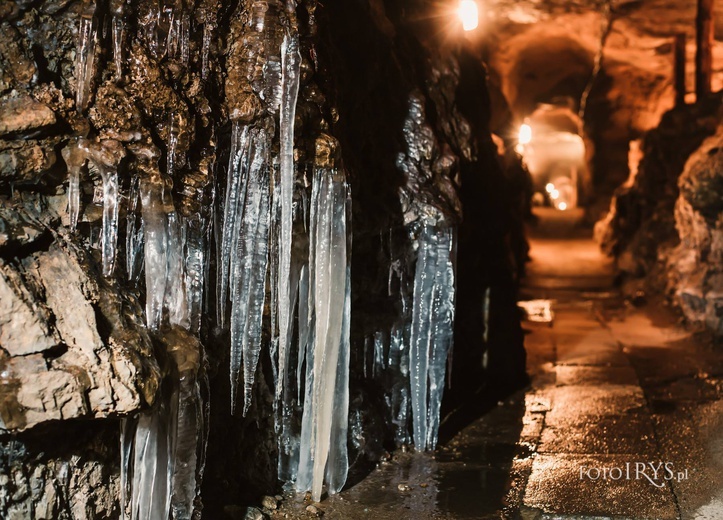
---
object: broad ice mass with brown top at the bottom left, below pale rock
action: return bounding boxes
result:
[121,328,206,520]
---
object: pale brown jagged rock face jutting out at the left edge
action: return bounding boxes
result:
[0,201,159,432]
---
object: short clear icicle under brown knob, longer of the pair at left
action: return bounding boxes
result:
[81,139,126,276]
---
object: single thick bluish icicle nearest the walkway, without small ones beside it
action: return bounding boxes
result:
[409,223,454,451]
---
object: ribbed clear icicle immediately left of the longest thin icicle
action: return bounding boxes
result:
[230,128,271,415]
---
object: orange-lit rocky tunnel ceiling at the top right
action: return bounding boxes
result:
[482,0,723,139]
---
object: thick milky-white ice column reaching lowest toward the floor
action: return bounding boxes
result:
[296,162,351,501]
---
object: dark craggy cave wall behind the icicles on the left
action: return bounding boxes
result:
[0,0,525,519]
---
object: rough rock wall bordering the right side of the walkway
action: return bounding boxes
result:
[595,94,723,337]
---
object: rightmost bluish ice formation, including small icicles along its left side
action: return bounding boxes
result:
[367,217,456,451]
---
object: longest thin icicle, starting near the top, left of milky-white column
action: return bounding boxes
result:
[276,22,301,399]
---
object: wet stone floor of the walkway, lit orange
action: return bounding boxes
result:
[272,210,723,520]
